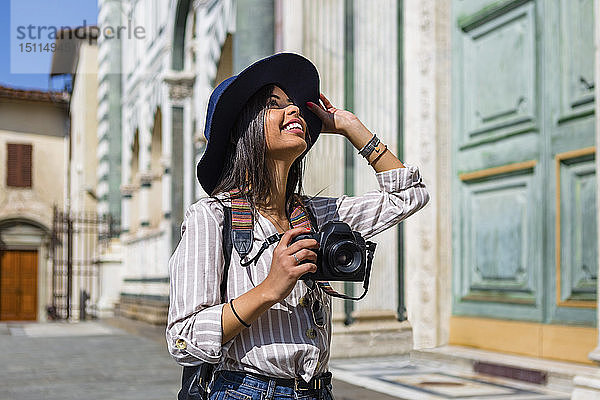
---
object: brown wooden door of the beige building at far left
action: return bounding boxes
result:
[0,251,38,321]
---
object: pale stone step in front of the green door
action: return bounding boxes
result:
[410,345,598,392]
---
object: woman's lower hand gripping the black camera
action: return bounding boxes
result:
[260,227,319,301]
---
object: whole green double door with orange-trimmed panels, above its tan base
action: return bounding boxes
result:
[452,0,598,325]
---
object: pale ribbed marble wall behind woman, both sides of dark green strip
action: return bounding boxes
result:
[278,0,398,319]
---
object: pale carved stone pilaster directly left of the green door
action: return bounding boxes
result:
[402,0,452,348]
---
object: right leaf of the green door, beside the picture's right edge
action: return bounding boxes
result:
[540,0,598,325]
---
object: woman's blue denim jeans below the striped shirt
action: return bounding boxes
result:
[209,371,334,400]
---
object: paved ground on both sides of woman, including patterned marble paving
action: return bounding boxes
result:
[0,318,570,400]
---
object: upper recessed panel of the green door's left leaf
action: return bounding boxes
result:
[461,4,536,146]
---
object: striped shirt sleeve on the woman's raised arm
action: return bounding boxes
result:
[310,164,429,239]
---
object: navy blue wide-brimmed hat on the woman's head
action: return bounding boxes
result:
[196,53,322,194]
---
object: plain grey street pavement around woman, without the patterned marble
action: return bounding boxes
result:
[0,318,397,400]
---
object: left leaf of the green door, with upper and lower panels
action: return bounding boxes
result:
[452,0,544,321]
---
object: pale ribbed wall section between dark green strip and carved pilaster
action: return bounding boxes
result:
[354,0,399,318]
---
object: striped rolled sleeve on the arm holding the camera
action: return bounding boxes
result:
[166,201,228,366]
